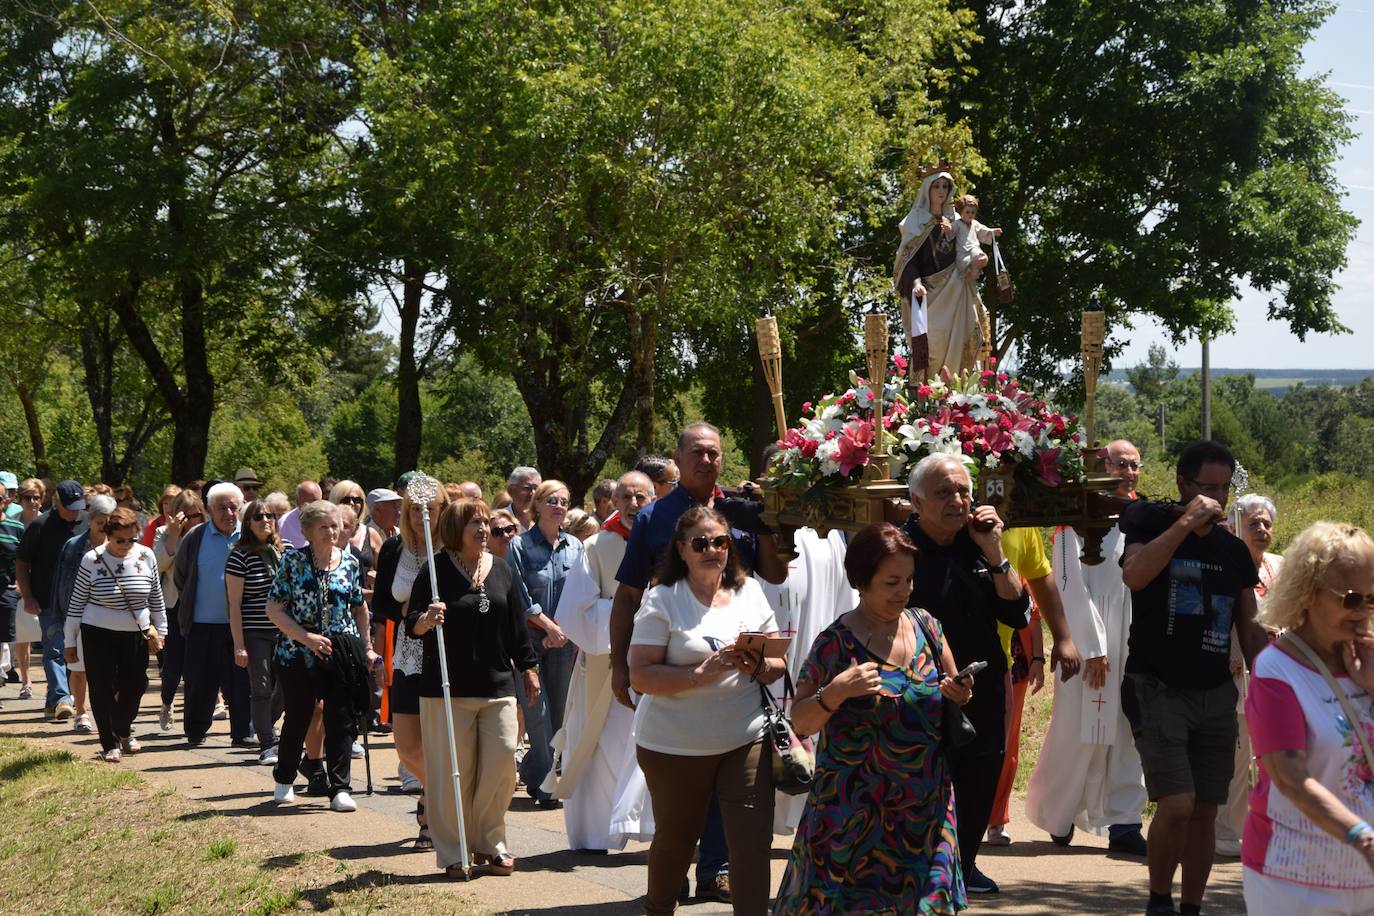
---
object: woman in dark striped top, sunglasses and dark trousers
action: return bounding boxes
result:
[224,500,282,766]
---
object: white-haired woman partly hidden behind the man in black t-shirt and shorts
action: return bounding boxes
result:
[1216,493,1283,858]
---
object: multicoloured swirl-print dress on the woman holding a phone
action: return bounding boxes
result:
[774,611,967,916]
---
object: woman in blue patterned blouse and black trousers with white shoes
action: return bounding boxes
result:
[267,500,381,812]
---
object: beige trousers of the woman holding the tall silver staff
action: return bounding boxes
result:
[420,696,517,868]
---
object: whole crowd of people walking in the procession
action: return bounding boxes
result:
[0,422,1374,916]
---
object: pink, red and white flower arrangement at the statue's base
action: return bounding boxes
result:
[768,354,1084,489]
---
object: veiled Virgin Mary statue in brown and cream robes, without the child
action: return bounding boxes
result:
[892,163,984,378]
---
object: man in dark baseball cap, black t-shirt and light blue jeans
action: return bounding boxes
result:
[15,481,85,721]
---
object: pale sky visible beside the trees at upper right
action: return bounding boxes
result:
[1116,0,1374,369]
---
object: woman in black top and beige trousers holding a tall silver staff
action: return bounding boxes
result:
[405,500,539,878]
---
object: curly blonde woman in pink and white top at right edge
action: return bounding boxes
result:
[1241,522,1374,916]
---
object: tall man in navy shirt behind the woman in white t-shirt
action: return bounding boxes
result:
[610,422,787,901]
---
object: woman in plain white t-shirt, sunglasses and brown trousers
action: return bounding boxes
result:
[629,507,783,913]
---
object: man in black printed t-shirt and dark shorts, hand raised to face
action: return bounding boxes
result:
[1121,441,1265,916]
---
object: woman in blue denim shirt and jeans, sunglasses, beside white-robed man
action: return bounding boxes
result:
[507,481,583,808]
